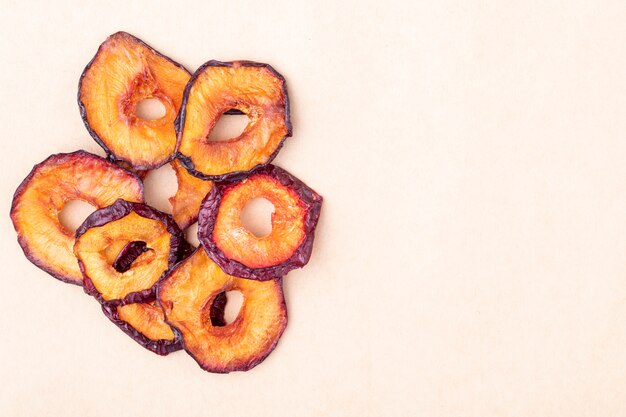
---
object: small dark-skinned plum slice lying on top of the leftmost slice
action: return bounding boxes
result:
[74,200,188,303]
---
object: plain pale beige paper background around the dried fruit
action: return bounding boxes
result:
[0,0,626,417]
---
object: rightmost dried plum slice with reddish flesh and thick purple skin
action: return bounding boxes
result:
[198,165,322,281]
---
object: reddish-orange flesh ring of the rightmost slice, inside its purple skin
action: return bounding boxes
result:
[213,175,306,268]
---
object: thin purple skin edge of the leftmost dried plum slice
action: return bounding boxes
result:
[11,149,144,286]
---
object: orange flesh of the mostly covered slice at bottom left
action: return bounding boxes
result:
[117,301,174,340]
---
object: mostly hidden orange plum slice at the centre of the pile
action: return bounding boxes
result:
[169,160,213,229]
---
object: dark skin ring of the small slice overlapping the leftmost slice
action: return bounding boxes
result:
[76,199,189,304]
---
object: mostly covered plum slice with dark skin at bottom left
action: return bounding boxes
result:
[102,290,182,356]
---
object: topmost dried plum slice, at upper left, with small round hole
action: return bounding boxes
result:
[78,32,190,170]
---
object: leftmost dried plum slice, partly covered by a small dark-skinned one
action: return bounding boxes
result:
[11,151,143,285]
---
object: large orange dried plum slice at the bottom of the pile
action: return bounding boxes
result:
[157,247,287,373]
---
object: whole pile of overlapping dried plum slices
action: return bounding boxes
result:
[11,32,322,373]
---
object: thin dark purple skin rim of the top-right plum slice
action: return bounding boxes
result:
[174,60,293,181]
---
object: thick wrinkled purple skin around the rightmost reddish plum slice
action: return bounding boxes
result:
[198,165,323,281]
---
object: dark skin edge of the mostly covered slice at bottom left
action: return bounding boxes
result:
[102,286,182,356]
